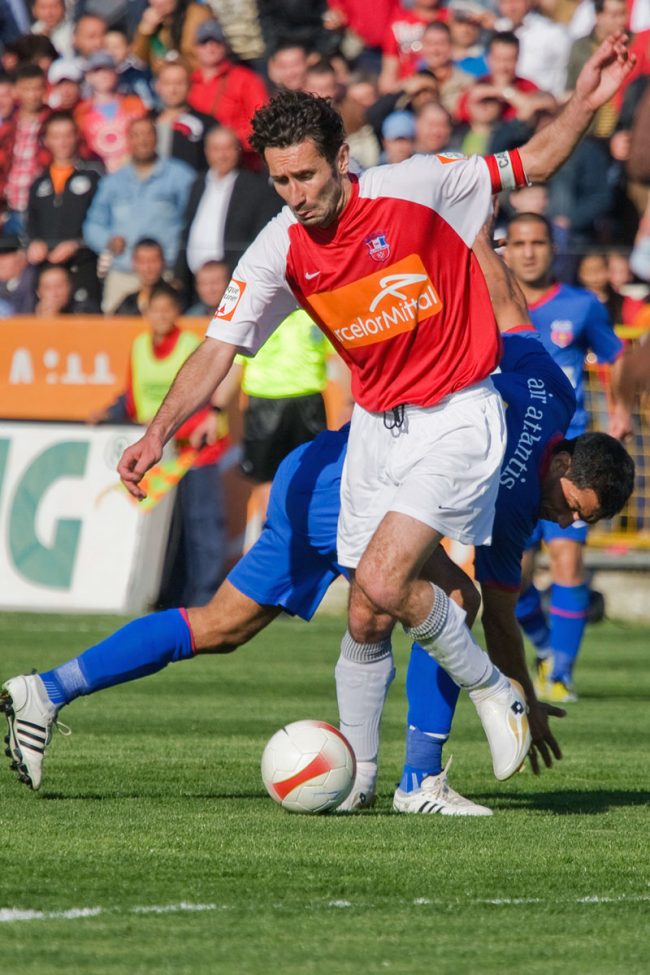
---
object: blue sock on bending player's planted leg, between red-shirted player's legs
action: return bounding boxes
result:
[400,643,460,792]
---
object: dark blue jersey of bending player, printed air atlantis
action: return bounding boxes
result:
[475,331,576,591]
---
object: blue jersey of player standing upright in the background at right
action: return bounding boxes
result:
[529,284,622,437]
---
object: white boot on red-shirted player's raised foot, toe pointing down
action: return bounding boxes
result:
[469,674,532,781]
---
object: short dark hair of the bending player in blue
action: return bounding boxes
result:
[553,433,634,518]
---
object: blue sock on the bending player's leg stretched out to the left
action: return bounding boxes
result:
[40,609,193,707]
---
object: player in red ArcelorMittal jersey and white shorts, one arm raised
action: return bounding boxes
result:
[118,35,633,779]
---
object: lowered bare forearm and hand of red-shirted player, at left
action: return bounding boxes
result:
[117,338,237,501]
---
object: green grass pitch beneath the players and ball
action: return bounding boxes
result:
[0,614,650,975]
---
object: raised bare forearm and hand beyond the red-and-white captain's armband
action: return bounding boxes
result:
[519,32,636,183]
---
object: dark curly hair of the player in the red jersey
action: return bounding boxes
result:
[250,91,345,165]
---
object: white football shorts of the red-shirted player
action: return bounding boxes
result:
[337,379,506,568]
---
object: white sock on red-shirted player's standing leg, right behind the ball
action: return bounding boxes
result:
[334,633,395,773]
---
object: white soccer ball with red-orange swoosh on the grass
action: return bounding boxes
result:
[262,721,357,813]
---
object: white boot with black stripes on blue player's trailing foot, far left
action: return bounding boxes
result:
[0,674,56,790]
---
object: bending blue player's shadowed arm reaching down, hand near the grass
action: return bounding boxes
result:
[482,586,566,775]
